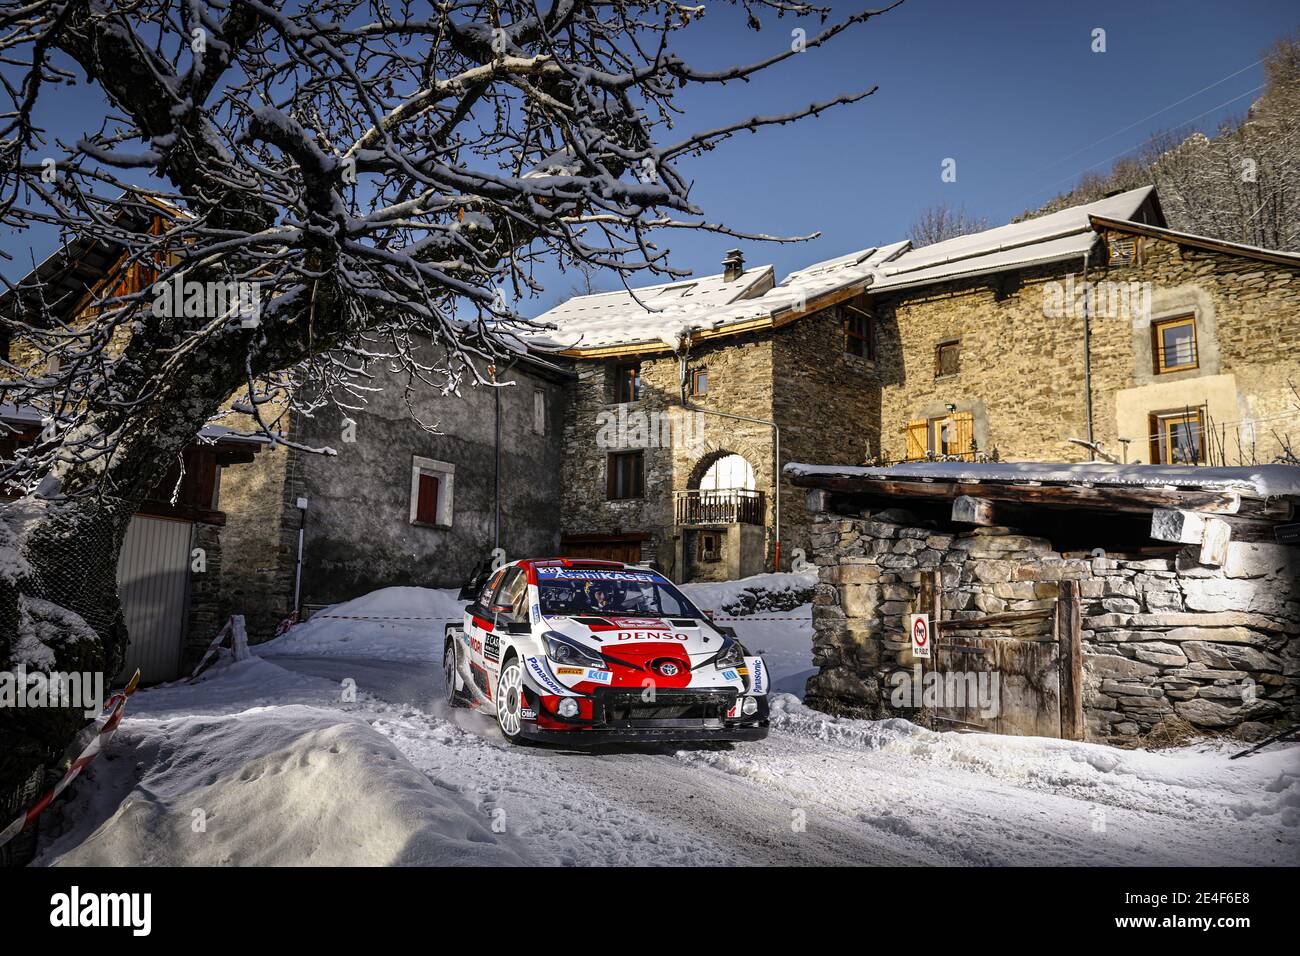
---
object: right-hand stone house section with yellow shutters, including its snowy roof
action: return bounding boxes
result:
[863,187,1300,466]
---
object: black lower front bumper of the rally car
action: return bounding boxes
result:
[520,688,768,747]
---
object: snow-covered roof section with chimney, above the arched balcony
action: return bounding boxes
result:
[532,265,772,349]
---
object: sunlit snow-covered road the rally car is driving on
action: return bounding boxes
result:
[276,657,1300,865]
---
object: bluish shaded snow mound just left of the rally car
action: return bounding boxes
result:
[257,588,465,661]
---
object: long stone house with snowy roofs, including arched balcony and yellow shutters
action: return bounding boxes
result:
[538,187,1300,580]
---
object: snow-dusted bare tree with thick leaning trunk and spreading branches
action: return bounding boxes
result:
[0,0,897,790]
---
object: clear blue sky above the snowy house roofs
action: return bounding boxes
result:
[0,0,1300,315]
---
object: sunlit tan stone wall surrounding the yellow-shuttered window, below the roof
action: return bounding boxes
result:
[873,238,1300,464]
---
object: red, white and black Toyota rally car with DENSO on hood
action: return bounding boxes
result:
[442,558,768,747]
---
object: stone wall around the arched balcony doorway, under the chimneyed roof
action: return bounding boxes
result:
[564,307,880,575]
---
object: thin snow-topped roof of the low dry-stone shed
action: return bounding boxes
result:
[785,462,1300,498]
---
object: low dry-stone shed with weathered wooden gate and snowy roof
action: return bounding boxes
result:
[787,462,1300,743]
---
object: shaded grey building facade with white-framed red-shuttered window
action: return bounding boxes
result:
[221,348,568,640]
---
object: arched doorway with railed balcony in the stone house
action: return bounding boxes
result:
[673,447,767,581]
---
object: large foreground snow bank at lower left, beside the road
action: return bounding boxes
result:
[36,681,524,866]
